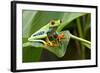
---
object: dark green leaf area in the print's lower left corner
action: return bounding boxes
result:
[22,46,42,63]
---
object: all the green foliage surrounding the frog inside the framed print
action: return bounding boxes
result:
[22,10,91,62]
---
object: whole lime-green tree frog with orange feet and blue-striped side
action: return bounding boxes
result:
[28,20,64,46]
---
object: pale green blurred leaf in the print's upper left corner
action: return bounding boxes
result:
[22,10,37,38]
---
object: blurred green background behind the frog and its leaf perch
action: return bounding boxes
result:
[22,10,91,63]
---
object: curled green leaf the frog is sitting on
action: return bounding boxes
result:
[23,31,70,57]
